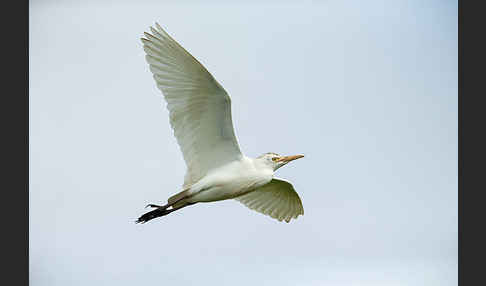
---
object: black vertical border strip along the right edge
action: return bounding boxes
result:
[458,1,486,285]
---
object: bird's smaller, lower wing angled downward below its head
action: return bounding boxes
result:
[235,178,304,222]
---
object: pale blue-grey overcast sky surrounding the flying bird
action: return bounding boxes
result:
[29,0,458,286]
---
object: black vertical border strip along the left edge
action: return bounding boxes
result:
[0,1,29,285]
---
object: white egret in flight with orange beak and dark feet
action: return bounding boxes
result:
[135,22,304,223]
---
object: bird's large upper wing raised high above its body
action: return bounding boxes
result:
[142,23,242,188]
